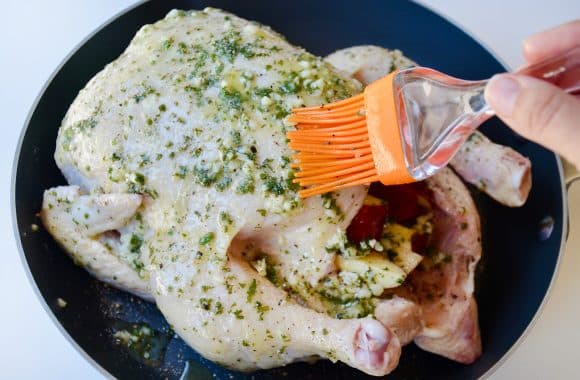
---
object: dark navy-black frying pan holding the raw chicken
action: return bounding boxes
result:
[13,0,566,379]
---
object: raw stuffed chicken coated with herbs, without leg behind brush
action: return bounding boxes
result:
[41,8,532,376]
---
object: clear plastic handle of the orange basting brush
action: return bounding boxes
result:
[402,46,580,180]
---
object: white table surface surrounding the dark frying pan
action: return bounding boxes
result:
[0,0,580,379]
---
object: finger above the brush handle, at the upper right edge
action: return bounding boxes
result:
[523,20,580,64]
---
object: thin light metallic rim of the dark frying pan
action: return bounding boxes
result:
[10,0,569,379]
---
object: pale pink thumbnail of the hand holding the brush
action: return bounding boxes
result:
[485,74,520,116]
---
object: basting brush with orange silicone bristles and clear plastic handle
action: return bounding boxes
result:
[288,47,580,197]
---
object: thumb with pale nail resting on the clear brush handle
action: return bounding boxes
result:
[485,74,580,168]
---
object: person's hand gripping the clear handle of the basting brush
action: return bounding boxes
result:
[485,20,580,169]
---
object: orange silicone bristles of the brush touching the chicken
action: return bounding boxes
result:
[287,94,378,198]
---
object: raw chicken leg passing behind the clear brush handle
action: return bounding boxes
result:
[325,45,532,207]
